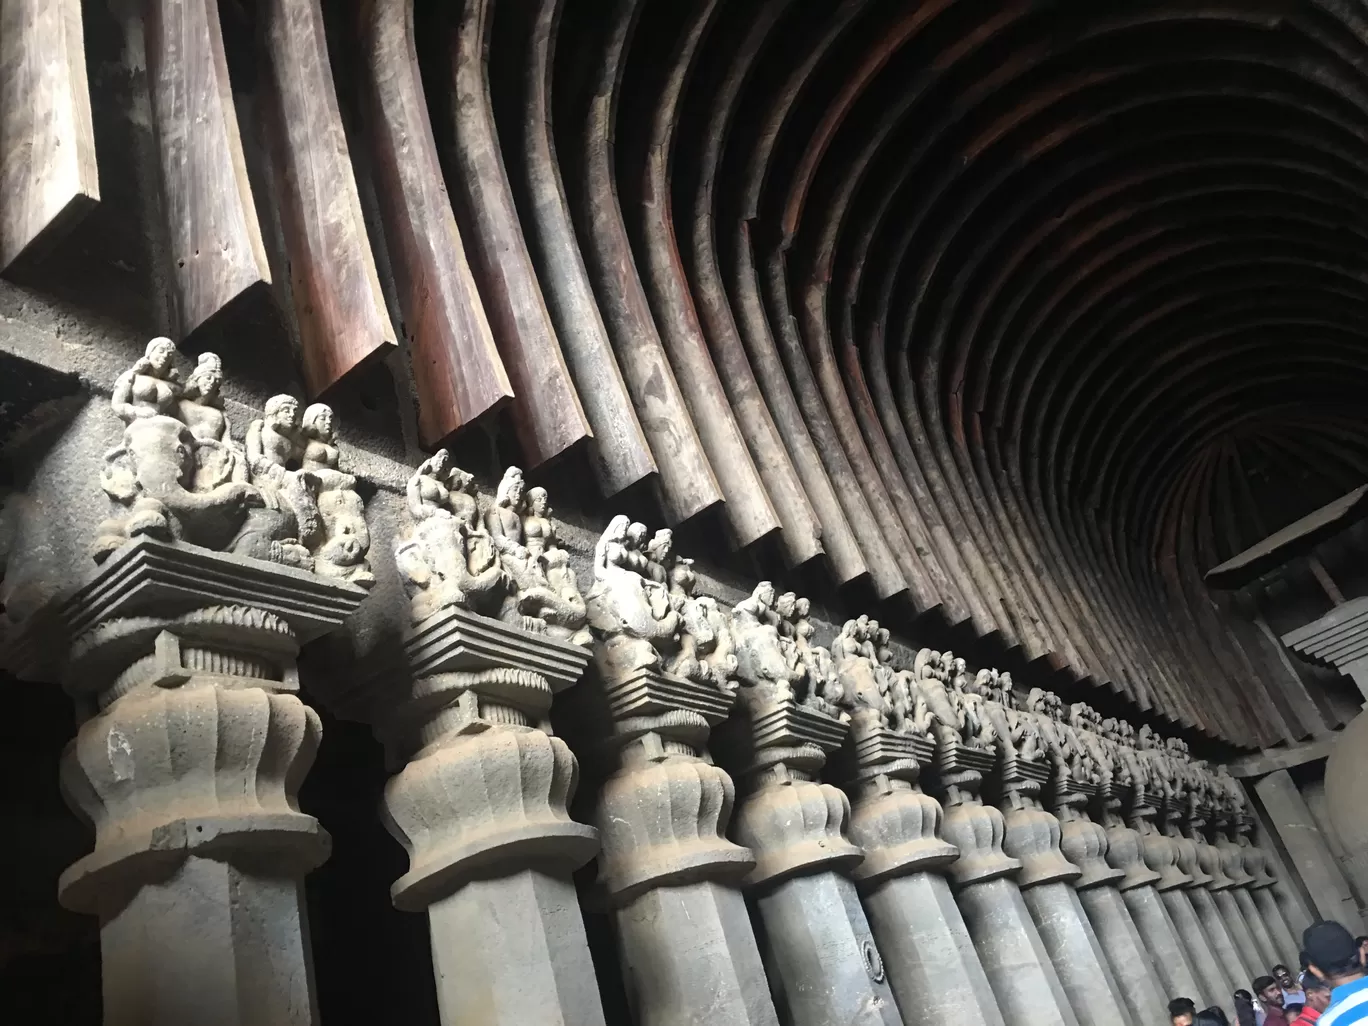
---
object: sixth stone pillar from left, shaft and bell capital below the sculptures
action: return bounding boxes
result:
[936,737,1078,1026]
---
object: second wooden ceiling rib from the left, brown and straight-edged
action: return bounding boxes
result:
[144,0,271,339]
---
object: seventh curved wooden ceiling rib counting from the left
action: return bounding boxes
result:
[572,0,722,524]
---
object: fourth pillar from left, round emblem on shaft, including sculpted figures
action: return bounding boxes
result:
[714,583,903,1026]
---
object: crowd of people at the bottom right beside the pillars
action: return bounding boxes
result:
[1168,921,1368,1026]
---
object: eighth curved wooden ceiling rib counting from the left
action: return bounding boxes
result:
[624,0,791,555]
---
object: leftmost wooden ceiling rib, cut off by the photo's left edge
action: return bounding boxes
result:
[0,0,100,271]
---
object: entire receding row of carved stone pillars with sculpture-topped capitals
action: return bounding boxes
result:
[2,339,1313,1026]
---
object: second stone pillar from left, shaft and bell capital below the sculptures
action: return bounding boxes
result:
[345,607,603,1026]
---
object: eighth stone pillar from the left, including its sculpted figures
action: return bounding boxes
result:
[1026,688,1167,1026]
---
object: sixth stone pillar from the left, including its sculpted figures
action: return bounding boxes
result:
[918,653,1078,1026]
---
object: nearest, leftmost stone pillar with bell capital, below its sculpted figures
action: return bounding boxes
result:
[52,538,365,1026]
